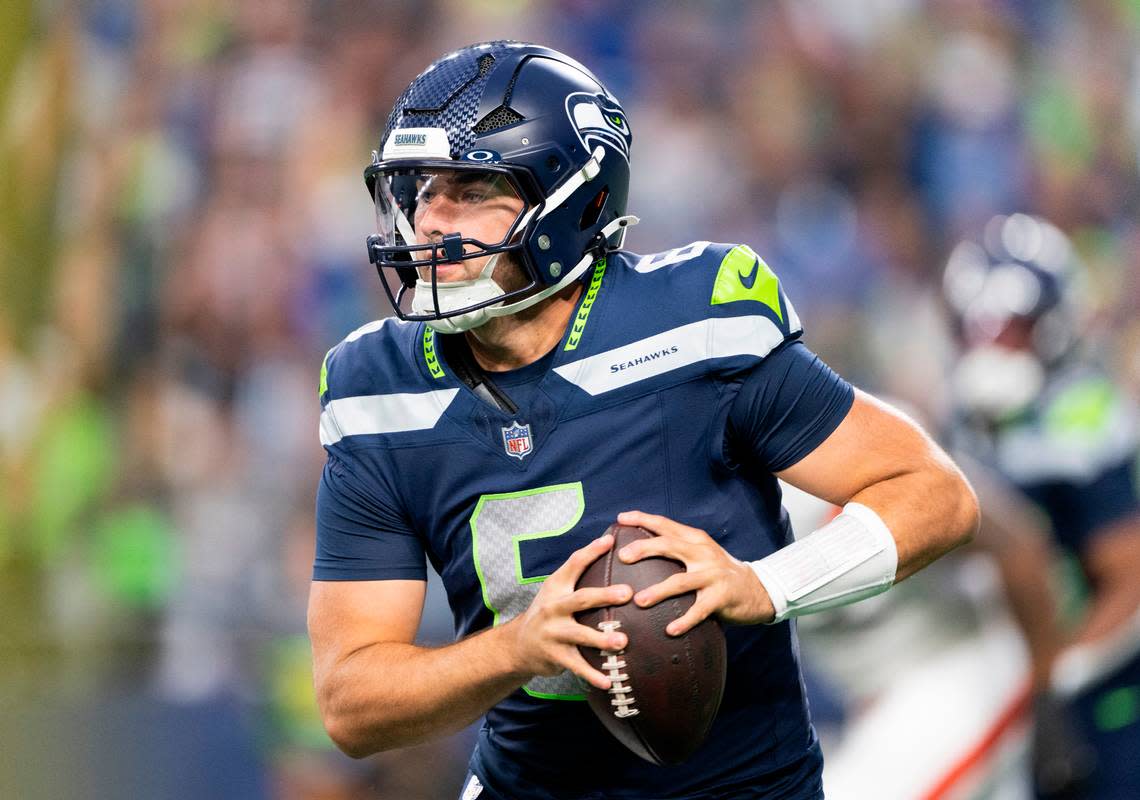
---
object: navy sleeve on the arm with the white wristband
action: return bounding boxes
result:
[725,341,855,472]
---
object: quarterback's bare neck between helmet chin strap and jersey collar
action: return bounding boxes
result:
[466,284,583,373]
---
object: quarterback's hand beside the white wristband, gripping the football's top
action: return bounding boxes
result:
[618,511,775,636]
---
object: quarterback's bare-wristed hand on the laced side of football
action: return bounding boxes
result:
[507,534,633,689]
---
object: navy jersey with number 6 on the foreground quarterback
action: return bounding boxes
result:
[314,243,853,798]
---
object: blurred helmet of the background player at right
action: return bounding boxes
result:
[943,214,1086,418]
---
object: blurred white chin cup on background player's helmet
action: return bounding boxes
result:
[953,344,1045,418]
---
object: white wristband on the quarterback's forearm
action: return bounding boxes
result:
[748,503,898,622]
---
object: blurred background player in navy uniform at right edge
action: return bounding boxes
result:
[943,214,1140,798]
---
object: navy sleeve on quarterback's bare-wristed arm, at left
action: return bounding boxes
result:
[312,455,428,580]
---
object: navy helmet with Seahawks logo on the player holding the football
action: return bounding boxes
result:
[365,41,636,333]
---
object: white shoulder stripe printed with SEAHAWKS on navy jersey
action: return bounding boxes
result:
[554,316,784,394]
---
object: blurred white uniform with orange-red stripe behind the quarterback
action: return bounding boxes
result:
[782,484,1032,800]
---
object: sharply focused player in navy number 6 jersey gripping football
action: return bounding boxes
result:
[309,42,977,800]
